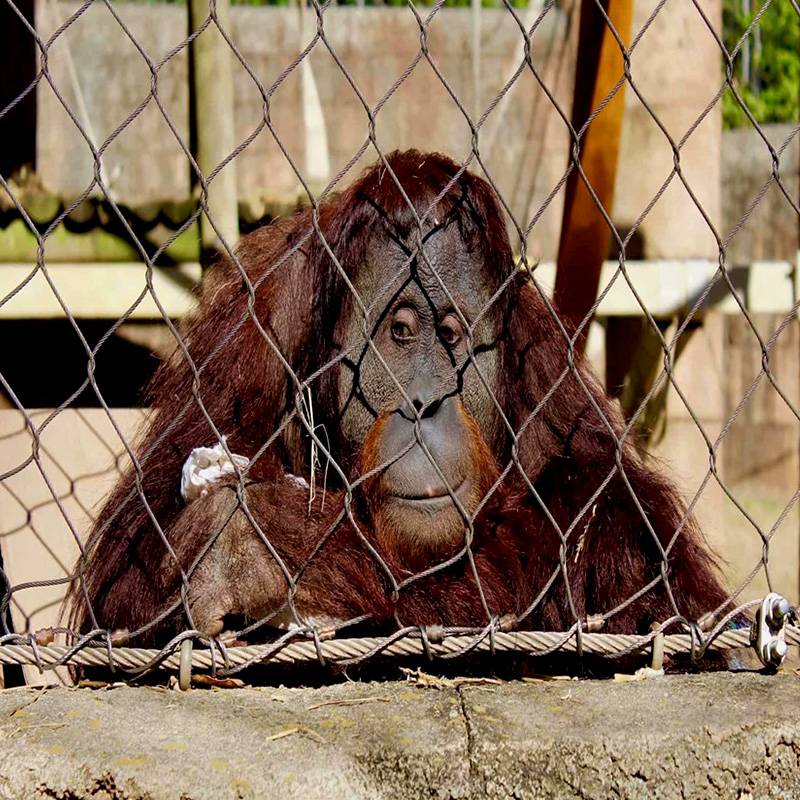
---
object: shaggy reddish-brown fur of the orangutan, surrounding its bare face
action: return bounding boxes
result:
[71,152,725,641]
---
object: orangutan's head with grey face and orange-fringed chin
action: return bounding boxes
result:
[318,152,513,562]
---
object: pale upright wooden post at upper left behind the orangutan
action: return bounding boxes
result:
[189,0,239,265]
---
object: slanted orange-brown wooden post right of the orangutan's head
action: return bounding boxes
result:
[554,0,633,350]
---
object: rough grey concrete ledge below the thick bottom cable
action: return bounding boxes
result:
[0,674,800,800]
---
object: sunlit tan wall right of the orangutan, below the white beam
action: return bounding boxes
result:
[655,313,800,602]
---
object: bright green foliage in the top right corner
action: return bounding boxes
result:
[722,0,800,128]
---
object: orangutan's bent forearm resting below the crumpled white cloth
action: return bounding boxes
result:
[161,476,389,636]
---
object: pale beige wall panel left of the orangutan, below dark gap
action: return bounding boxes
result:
[0,409,144,679]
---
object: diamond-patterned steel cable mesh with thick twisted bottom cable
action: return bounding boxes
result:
[0,0,800,674]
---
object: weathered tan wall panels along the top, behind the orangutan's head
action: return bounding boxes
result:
[37,0,721,260]
